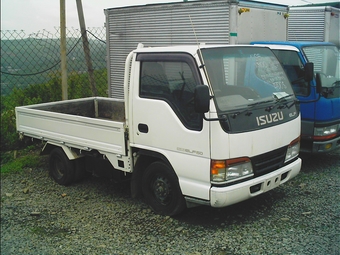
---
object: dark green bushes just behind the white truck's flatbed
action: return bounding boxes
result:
[1,69,107,151]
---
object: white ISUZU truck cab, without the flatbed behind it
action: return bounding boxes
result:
[125,45,301,214]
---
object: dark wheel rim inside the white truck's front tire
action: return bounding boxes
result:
[151,176,171,205]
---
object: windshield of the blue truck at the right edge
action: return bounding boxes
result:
[303,45,340,87]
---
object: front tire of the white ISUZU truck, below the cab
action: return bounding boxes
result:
[142,161,186,216]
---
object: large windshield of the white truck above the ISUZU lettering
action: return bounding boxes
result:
[202,46,294,111]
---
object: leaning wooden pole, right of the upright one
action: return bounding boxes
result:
[76,0,97,96]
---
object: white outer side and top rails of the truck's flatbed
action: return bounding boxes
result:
[16,98,130,171]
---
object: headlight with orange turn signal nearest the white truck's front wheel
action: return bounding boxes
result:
[211,158,253,183]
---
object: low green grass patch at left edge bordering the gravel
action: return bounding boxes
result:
[1,145,43,176]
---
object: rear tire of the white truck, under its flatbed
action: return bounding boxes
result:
[49,148,75,186]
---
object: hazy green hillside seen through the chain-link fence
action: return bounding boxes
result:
[0,35,106,95]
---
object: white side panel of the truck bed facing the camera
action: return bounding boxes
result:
[17,108,125,154]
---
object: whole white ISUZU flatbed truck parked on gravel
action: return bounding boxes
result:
[16,45,301,215]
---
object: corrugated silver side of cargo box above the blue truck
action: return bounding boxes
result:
[288,8,325,42]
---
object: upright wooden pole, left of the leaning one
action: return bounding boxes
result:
[60,0,68,100]
